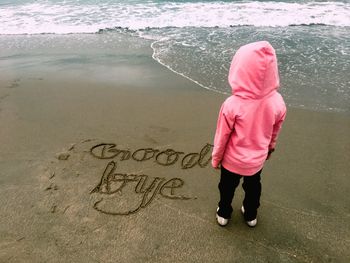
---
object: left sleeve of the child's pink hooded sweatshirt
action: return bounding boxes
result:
[212,103,235,168]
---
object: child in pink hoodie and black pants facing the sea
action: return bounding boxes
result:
[212,41,286,227]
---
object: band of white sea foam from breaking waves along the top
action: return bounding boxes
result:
[0,1,350,34]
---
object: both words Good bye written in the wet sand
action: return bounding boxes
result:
[90,143,213,215]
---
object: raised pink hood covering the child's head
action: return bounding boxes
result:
[228,41,279,99]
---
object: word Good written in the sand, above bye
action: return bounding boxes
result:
[90,143,213,169]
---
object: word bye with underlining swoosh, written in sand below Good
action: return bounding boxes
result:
[91,161,191,215]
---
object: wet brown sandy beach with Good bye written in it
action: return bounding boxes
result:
[0,33,350,263]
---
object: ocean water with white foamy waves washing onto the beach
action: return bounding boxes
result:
[0,0,350,113]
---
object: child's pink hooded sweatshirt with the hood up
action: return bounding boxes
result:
[212,41,286,176]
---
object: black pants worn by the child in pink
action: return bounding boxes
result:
[218,166,262,221]
